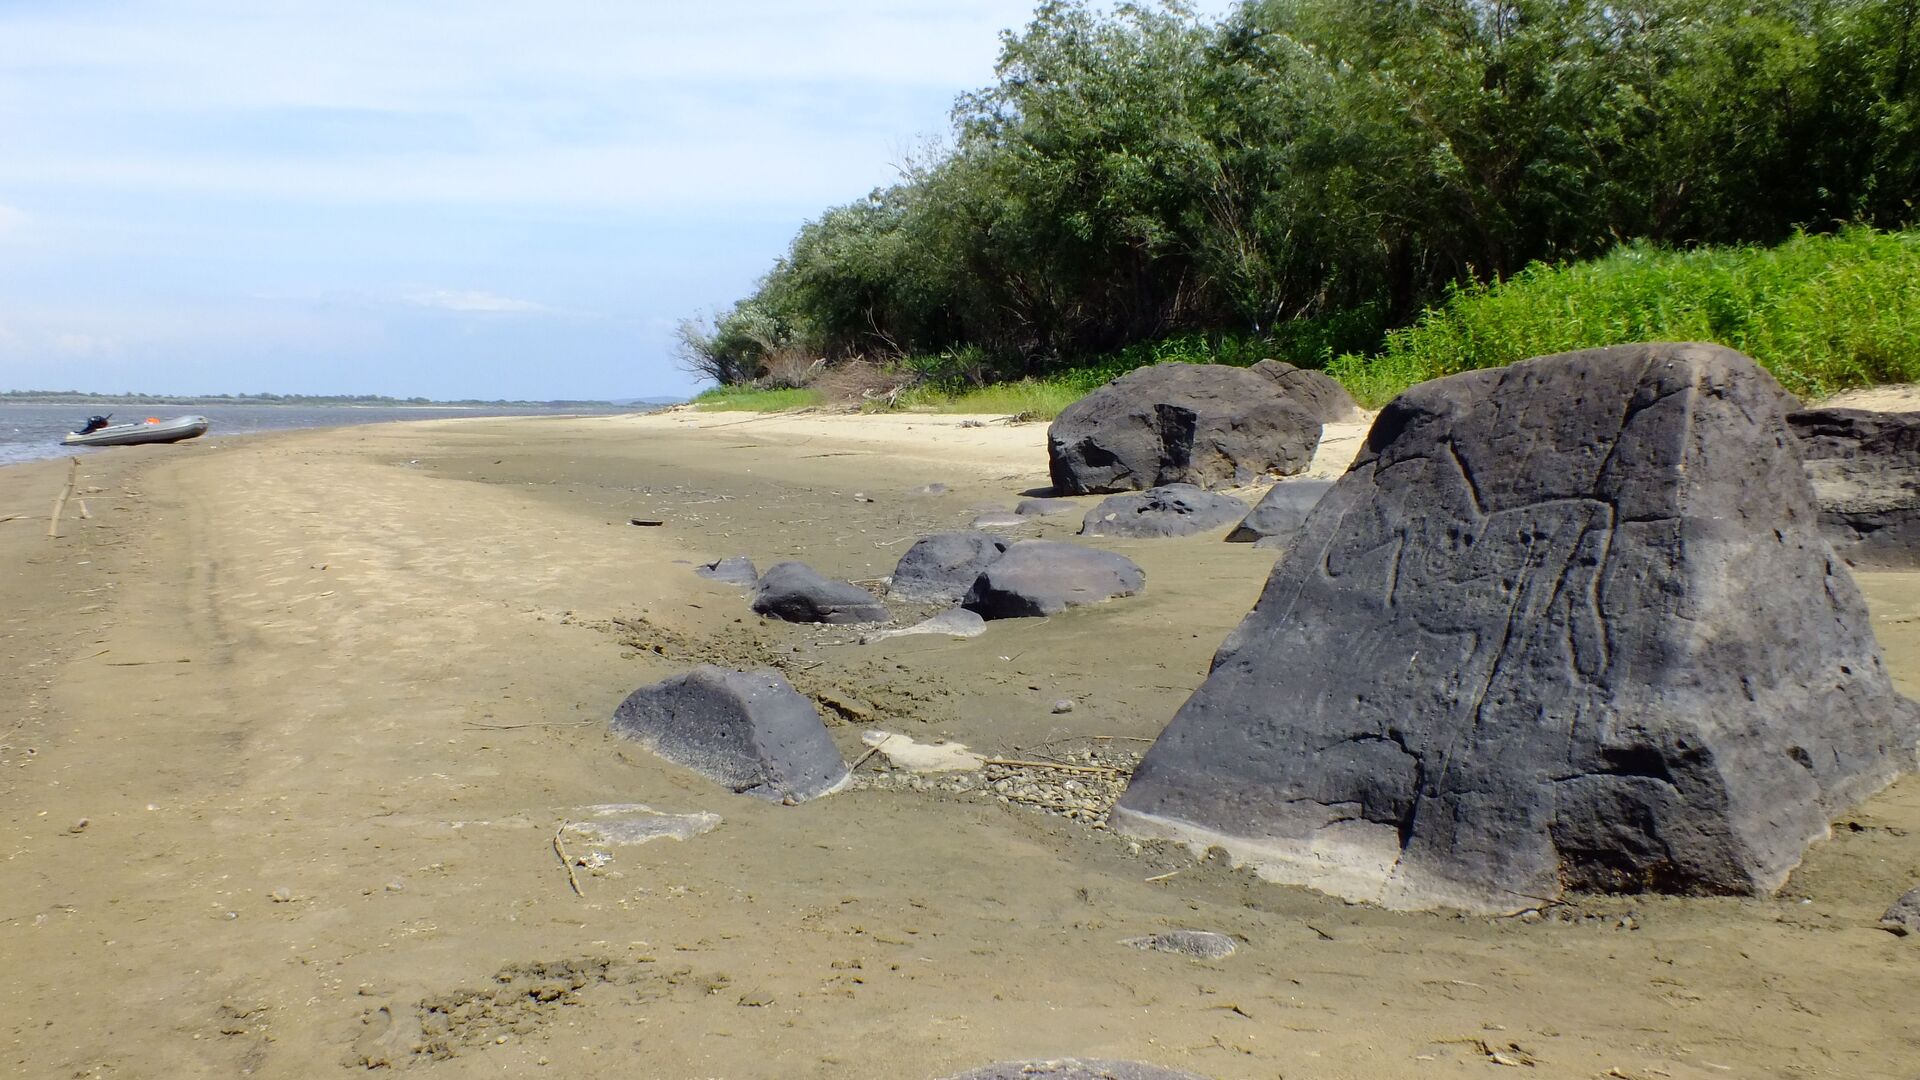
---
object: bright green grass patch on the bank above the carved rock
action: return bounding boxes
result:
[1327,229,1920,405]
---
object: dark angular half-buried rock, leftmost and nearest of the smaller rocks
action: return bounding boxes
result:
[612,665,847,803]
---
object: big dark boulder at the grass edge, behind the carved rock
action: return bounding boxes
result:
[1046,363,1321,496]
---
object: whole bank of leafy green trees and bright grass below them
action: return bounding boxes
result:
[680,0,1920,419]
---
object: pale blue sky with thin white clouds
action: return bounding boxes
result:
[0,0,1213,400]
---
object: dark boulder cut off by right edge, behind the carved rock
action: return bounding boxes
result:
[1788,409,1920,569]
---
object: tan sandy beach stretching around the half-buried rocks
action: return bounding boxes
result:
[0,411,1920,1080]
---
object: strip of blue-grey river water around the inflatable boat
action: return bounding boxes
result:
[0,402,629,465]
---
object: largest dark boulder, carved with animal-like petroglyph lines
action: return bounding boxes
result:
[1114,344,1920,913]
